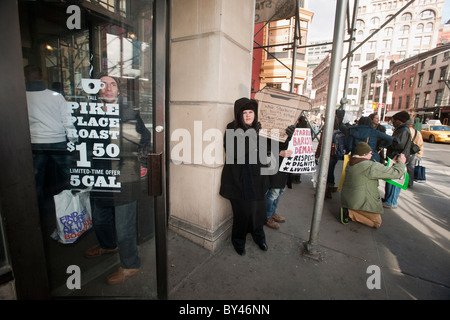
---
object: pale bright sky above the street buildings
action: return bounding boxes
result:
[306,0,450,42]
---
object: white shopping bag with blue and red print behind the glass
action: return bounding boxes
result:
[52,189,92,244]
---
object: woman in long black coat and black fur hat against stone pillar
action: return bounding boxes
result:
[219,98,269,255]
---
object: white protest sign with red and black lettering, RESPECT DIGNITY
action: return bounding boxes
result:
[279,128,316,173]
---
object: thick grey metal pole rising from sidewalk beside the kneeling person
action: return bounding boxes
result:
[305,0,347,255]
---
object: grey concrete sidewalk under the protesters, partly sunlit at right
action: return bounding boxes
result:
[168,162,450,300]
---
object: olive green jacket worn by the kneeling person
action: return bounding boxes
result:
[341,158,406,214]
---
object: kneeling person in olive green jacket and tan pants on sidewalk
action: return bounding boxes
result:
[340,142,406,228]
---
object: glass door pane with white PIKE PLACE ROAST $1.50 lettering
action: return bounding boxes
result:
[18,0,165,299]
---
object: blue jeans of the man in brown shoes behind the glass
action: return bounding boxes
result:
[92,200,141,269]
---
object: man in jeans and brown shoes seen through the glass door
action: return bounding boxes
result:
[85,73,151,284]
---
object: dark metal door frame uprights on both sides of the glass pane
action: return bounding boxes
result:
[0,0,170,300]
